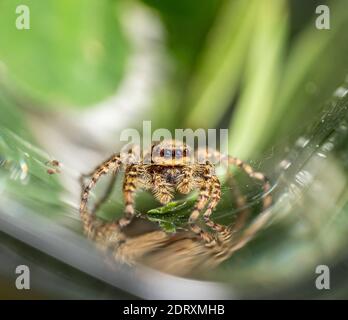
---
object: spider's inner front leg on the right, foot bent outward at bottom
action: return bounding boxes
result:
[189,166,215,243]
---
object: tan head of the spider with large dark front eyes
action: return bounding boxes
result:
[151,140,192,166]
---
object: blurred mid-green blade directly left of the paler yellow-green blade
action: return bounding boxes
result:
[185,0,259,128]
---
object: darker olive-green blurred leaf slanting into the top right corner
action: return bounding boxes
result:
[258,0,348,154]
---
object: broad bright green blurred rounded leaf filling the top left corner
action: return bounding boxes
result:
[0,0,128,107]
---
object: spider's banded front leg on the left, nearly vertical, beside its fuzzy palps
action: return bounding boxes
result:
[118,165,139,228]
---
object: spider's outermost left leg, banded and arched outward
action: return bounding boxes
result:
[80,155,121,237]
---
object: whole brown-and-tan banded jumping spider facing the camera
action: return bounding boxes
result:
[80,140,272,243]
